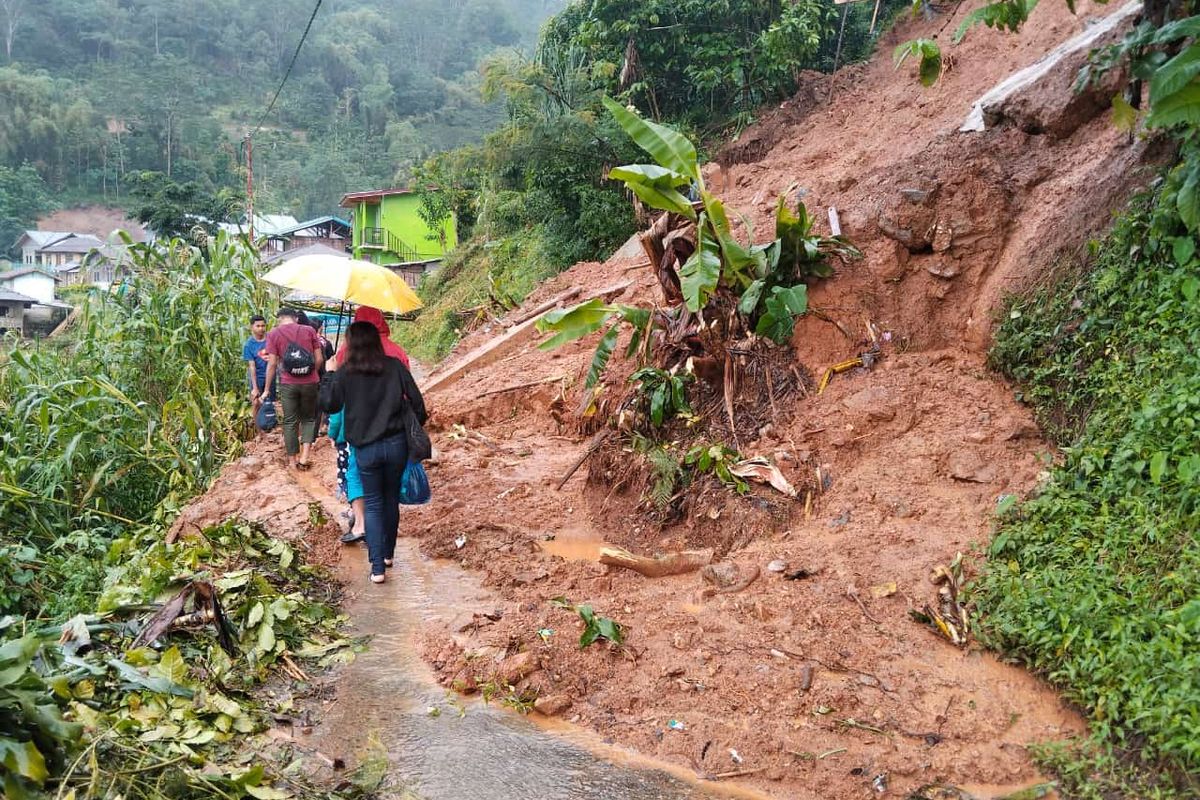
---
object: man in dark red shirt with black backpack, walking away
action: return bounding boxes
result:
[264,308,325,469]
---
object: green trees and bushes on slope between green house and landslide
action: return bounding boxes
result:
[393,0,905,360]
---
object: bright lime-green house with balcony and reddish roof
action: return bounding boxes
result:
[342,188,458,283]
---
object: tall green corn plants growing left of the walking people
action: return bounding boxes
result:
[0,235,269,568]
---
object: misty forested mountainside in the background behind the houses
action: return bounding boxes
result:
[0,0,563,216]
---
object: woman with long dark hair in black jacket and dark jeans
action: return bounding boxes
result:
[322,323,427,583]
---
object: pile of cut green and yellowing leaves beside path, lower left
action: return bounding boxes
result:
[0,523,359,800]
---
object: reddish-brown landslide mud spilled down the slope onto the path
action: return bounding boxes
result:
[181,0,1160,799]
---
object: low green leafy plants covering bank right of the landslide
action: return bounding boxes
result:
[973,185,1200,798]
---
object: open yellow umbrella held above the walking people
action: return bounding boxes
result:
[263,255,424,314]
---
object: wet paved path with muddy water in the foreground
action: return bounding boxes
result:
[312,540,766,800]
